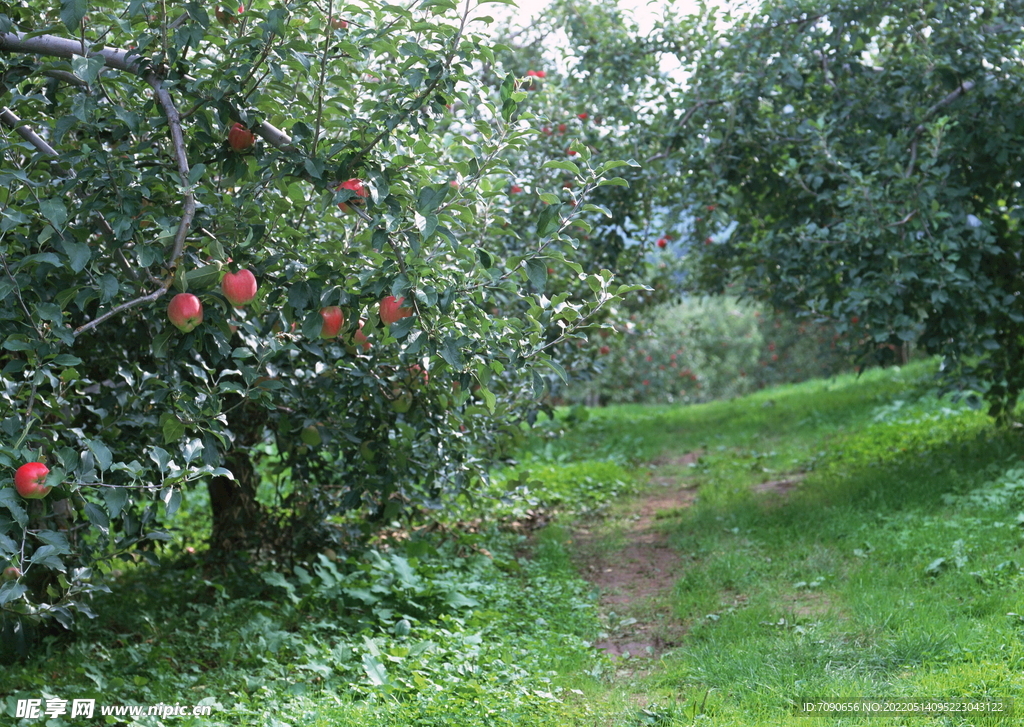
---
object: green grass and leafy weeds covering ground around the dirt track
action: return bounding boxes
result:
[8,361,1024,727]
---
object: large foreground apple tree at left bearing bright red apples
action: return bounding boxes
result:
[0,0,634,638]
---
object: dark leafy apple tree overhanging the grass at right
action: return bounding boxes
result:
[677,0,1024,420]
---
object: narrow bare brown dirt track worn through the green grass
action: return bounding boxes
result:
[571,453,699,657]
